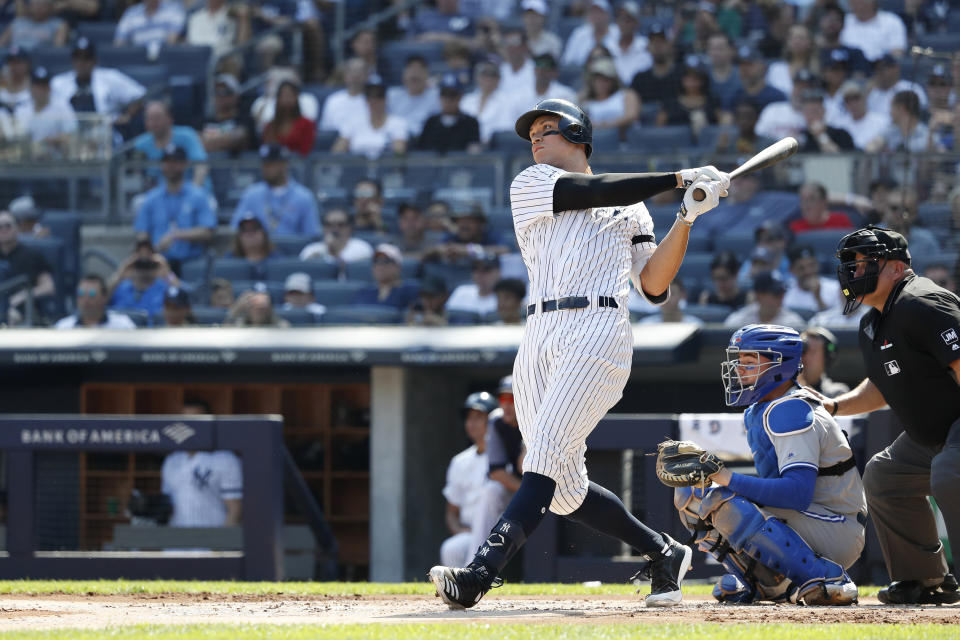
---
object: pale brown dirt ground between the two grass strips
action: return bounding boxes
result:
[0,594,960,631]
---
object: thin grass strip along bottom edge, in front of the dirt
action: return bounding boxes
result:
[0,623,958,640]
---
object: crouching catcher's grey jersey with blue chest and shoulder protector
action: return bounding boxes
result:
[743,387,866,514]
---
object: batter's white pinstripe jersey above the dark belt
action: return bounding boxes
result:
[510,164,657,304]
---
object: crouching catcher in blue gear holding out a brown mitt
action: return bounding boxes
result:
[657,324,867,605]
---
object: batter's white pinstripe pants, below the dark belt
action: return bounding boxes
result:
[513,304,633,515]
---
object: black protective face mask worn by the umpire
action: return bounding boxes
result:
[836,226,910,314]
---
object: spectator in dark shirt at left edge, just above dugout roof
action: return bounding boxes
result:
[0,211,57,324]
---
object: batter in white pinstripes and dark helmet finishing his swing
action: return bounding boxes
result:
[429,99,729,607]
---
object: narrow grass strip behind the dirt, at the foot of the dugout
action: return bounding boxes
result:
[0,580,879,597]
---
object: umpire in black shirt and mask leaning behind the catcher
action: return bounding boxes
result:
[823,226,960,604]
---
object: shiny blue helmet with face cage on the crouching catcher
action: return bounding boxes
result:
[720,324,803,407]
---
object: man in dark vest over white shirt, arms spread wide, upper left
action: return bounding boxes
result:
[50,38,147,127]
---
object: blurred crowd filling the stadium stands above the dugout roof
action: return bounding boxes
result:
[0,0,960,329]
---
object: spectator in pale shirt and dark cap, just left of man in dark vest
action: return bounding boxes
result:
[14,67,77,157]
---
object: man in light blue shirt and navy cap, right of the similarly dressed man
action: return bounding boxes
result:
[230,145,320,238]
